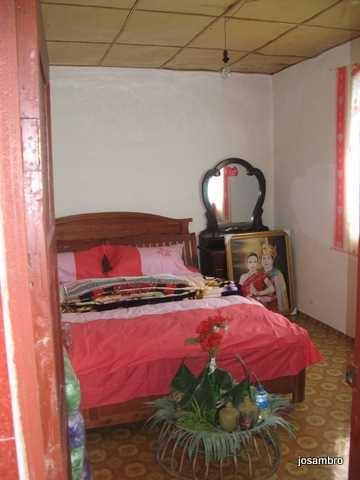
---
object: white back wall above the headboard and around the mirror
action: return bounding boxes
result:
[50,67,273,231]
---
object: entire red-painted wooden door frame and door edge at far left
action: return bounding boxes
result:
[0,0,70,480]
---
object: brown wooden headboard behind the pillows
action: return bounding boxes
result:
[56,212,198,267]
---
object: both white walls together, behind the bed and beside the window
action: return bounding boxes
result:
[51,47,359,334]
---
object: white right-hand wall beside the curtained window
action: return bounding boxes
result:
[273,43,356,334]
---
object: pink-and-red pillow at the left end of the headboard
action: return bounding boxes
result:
[57,245,106,283]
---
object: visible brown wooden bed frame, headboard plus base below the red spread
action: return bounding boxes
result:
[56,212,305,428]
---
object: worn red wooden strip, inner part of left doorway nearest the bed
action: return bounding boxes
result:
[17,0,70,472]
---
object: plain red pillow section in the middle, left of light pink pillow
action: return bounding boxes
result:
[104,245,142,277]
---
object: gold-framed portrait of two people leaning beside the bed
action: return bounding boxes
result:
[226,230,295,314]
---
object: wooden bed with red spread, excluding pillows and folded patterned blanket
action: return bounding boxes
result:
[56,212,320,428]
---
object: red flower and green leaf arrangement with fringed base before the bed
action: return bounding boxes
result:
[150,315,292,478]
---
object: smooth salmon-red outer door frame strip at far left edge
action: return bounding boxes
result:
[0,2,45,479]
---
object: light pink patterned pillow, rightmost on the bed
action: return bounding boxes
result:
[138,243,192,275]
